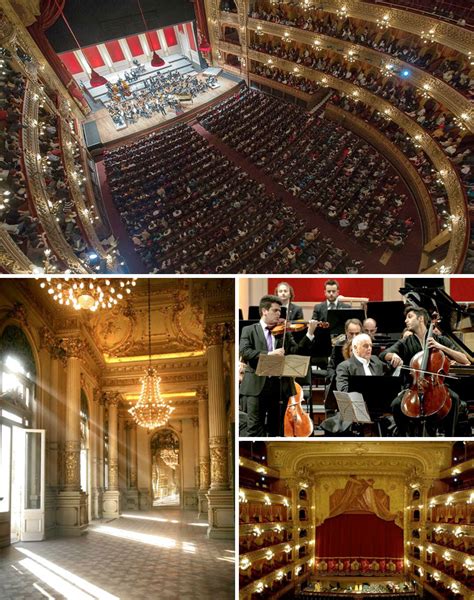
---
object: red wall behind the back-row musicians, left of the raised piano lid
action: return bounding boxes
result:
[268,275,383,303]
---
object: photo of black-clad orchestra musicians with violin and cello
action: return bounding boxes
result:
[238,275,474,438]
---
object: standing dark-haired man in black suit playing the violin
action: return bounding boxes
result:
[239,295,317,437]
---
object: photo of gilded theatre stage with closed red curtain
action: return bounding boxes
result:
[239,441,474,600]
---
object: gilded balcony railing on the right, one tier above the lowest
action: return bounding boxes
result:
[248,18,474,132]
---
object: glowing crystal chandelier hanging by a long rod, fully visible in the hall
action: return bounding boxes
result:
[128,279,174,430]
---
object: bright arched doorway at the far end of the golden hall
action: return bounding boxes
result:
[151,429,181,506]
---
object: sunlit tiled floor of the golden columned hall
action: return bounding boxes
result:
[0,509,234,600]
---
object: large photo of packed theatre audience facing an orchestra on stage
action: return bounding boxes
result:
[0,0,474,274]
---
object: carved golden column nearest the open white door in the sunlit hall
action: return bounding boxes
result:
[57,338,88,535]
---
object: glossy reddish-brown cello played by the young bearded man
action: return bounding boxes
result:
[401,315,452,420]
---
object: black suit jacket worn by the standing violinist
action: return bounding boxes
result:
[239,323,312,396]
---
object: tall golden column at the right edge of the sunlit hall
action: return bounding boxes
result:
[205,323,234,538]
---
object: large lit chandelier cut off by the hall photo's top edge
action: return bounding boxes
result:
[40,277,136,312]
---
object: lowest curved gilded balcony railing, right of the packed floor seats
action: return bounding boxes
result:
[248,50,469,273]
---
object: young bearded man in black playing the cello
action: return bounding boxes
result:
[379,306,470,436]
